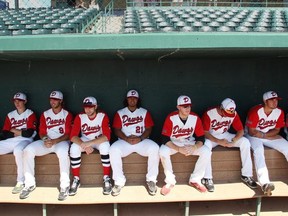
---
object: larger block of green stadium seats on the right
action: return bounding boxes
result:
[123,8,288,33]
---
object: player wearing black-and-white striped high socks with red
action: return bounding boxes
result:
[69,97,112,196]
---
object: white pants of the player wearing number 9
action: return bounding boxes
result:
[23,140,70,188]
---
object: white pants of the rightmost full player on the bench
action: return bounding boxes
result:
[246,135,288,186]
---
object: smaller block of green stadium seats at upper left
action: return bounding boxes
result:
[0,8,99,36]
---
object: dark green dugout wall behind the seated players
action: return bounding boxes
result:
[0,58,288,141]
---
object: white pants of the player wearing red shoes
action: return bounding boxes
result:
[160,144,211,185]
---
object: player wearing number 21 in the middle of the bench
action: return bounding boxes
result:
[110,90,159,196]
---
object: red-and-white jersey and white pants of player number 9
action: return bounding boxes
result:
[24,109,73,188]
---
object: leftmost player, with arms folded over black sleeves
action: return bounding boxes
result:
[0,92,37,194]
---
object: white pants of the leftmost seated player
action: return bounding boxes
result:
[0,136,33,183]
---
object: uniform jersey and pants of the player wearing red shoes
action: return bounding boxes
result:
[160,111,211,185]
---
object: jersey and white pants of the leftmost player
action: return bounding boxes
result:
[0,109,36,183]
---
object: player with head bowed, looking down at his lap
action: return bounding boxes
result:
[202,98,257,192]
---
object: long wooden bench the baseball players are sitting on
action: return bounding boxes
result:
[0,147,288,215]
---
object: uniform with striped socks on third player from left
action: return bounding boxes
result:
[70,112,111,177]
